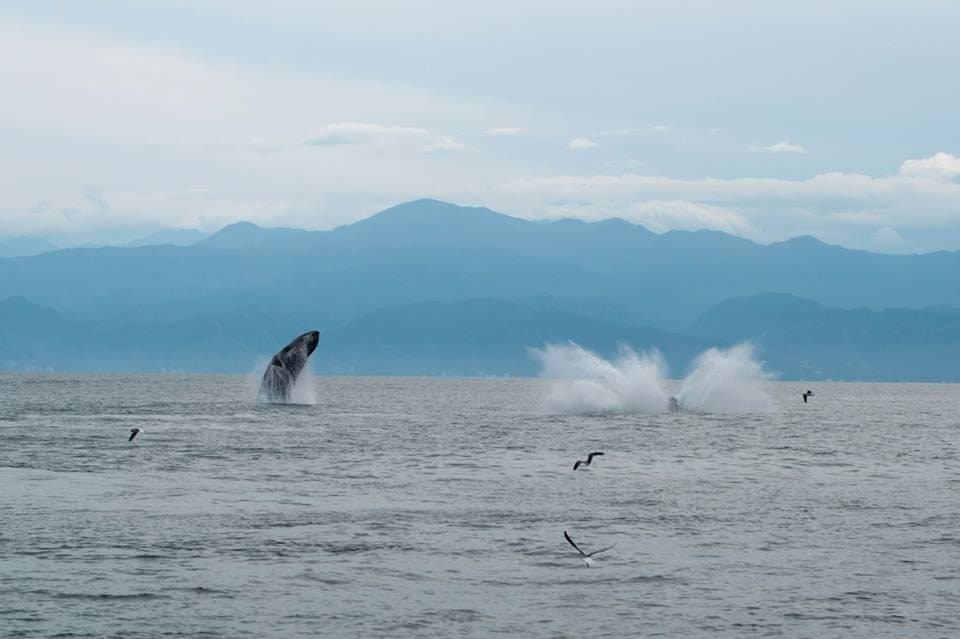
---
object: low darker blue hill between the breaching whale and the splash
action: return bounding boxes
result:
[315,299,708,375]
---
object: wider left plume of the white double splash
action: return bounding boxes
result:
[531,342,669,414]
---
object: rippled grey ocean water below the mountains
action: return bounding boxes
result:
[0,375,960,638]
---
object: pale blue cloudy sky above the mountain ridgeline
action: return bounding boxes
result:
[0,0,960,253]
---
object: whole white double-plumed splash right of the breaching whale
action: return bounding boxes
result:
[530,342,773,415]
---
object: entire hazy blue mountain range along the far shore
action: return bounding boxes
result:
[0,200,960,381]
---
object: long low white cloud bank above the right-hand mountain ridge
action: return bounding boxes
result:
[497,161,960,248]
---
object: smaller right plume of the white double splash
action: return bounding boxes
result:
[677,344,773,413]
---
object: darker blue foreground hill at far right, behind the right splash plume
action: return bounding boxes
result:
[688,294,960,381]
